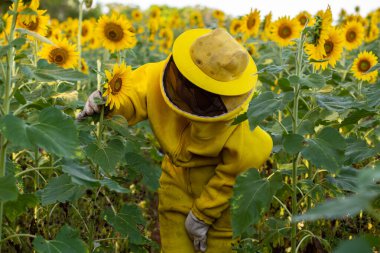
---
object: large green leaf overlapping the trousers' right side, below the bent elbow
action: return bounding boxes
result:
[231,169,282,237]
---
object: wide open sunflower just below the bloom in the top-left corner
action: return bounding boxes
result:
[38,39,78,69]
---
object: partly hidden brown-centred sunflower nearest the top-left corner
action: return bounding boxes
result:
[17,10,49,36]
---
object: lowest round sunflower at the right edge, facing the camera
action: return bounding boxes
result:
[351,51,378,82]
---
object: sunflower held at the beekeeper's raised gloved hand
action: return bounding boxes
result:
[103,63,132,109]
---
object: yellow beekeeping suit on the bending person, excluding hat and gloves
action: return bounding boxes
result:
[112,56,272,253]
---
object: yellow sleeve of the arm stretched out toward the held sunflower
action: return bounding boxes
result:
[108,63,157,125]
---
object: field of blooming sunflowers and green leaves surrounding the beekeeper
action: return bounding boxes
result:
[0,0,380,253]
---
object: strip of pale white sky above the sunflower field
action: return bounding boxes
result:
[94,0,380,19]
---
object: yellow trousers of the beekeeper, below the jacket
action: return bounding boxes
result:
[158,156,233,253]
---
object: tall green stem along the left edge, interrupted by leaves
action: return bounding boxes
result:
[0,0,19,249]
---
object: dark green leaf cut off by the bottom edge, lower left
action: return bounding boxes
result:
[33,225,89,253]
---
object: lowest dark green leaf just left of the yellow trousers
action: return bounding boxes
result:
[104,204,148,244]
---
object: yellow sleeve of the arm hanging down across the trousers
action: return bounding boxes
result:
[192,123,273,224]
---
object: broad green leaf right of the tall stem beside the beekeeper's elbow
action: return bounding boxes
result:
[301,127,346,172]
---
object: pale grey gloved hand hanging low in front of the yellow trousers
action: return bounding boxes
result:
[185,211,210,252]
